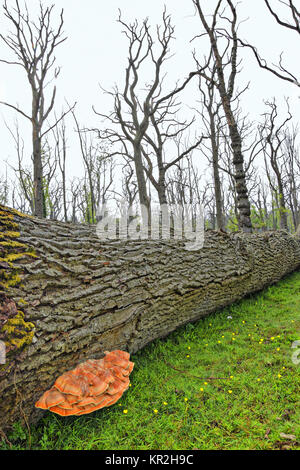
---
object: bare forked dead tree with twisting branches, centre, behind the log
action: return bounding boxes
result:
[95,10,196,222]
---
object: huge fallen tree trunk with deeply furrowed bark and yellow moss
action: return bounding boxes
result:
[0,206,300,430]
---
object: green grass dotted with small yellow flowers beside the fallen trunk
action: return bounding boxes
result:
[0,272,300,450]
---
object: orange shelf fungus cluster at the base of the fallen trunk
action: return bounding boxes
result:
[35,350,134,416]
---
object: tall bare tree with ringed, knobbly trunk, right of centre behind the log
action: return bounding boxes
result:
[190,0,252,232]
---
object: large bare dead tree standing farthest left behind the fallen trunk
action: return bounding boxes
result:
[0,0,75,218]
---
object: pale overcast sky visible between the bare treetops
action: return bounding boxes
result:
[0,0,300,184]
